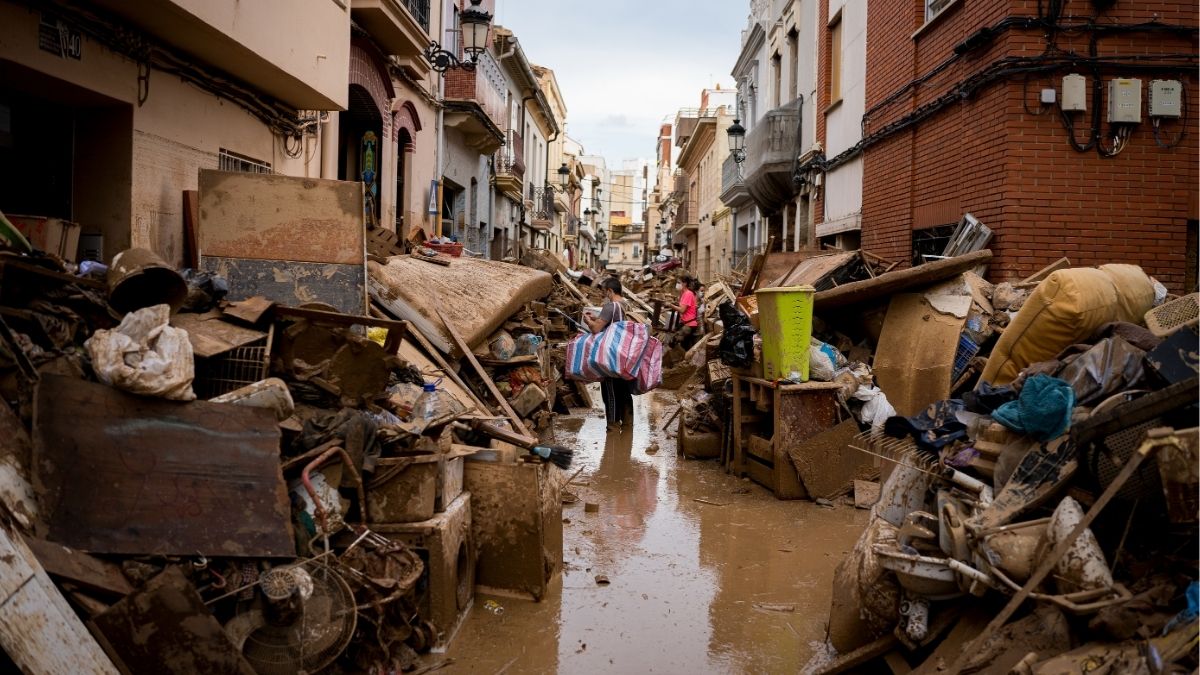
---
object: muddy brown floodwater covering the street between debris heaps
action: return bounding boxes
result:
[442,393,866,674]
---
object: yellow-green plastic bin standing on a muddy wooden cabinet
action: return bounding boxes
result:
[754,286,816,382]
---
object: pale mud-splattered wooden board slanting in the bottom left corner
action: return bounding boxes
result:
[0,526,119,675]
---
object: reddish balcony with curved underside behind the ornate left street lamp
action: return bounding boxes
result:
[445,52,508,155]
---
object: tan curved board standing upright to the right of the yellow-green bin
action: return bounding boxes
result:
[874,293,966,417]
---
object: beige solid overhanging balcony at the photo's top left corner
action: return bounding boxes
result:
[95,0,348,110]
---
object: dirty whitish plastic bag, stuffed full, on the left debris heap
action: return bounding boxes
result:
[84,305,196,401]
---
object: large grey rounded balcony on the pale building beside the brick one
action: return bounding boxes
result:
[743,100,800,214]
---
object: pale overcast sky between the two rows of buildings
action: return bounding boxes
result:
[496,0,750,168]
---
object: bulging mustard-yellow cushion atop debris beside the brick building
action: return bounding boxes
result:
[980,264,1154,386]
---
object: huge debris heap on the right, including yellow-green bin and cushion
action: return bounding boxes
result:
[680,239,1200,674]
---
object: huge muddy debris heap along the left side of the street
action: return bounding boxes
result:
[0,234,576,674]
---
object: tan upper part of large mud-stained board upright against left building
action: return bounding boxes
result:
[199,171,366,264]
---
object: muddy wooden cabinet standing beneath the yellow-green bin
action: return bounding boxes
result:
[726,374,841,500]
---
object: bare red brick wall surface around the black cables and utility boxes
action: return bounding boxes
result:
[859,0,1200,285]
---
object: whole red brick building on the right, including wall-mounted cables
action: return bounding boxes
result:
[815,0,1200,292]
